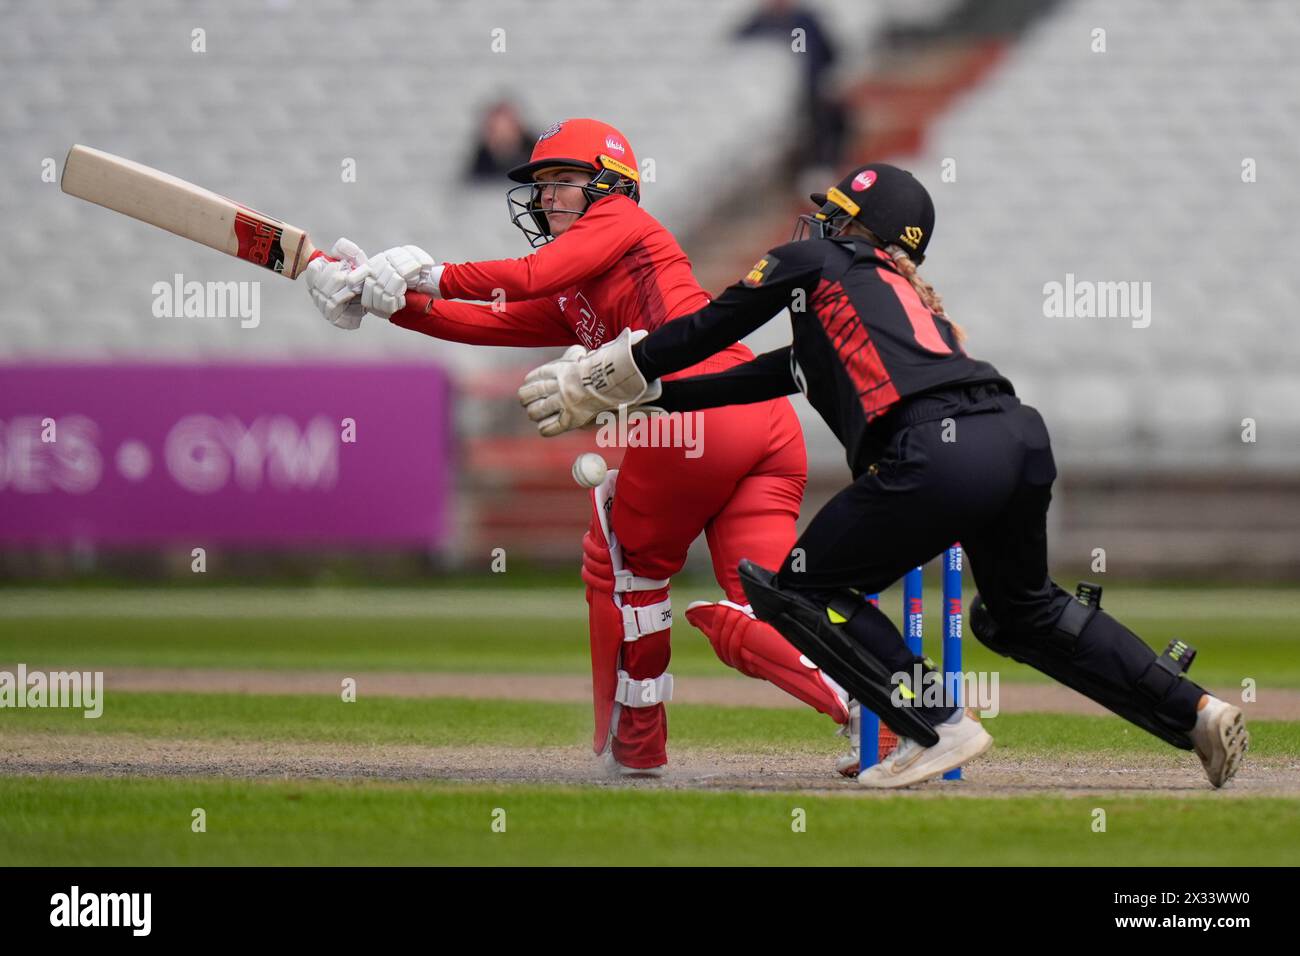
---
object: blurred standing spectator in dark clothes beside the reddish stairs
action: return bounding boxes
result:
[736,0,846,169]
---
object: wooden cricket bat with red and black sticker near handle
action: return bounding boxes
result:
[59,146,325,278]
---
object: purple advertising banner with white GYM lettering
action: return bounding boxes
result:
[0,364,452,548]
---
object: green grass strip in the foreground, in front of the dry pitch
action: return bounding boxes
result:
[0,778,1296,866]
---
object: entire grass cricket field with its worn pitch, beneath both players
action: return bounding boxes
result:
[0,589,1300,865]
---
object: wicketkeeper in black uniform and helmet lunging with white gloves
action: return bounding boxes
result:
[520,164,1248,787]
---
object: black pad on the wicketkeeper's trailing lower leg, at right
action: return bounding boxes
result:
[970,581,1203,750]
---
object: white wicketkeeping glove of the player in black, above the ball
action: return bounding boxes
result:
[519,329,663,438]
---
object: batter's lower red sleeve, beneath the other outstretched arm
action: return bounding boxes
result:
[391,293,577,346]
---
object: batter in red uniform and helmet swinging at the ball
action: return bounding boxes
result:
[313,120,848,773]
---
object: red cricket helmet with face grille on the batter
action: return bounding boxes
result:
[506,120,641,247]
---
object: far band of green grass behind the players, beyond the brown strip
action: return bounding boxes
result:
[0,588,1300,688]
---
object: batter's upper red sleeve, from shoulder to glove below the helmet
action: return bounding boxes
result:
[438,196,642,300]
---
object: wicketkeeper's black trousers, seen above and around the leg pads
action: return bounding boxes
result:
[777,388,1201,730]
